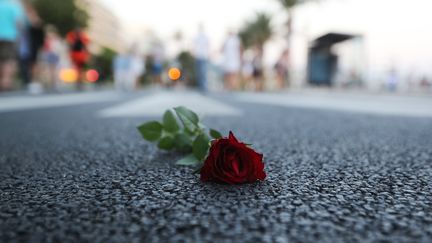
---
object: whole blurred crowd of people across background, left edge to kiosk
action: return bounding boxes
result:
[0,0,288,94]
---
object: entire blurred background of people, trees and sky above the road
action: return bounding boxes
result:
[0,0,432,94]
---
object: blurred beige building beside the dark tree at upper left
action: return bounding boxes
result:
[77,0,124,53]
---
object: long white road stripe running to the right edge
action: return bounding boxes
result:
[236,92,432,117]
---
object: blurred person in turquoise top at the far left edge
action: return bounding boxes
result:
[0,0,24,91]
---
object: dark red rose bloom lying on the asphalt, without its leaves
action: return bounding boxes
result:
[201,132,266,184]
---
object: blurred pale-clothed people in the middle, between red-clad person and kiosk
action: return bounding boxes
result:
[113,25,289,92]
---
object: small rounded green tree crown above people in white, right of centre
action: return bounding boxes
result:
[239,13,273,48]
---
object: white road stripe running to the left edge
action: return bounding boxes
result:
[0,91,120,112]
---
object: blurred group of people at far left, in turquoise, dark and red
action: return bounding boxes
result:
[0,0,90,94]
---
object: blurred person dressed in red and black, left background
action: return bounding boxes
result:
[66,28,90,90]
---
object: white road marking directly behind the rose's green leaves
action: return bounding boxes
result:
[98,91,242,117]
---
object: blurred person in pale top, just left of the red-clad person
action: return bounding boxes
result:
[42,26,62,89]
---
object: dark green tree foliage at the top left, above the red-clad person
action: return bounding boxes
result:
[33,0,89,36]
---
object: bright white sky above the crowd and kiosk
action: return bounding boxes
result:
[100,0,432,77]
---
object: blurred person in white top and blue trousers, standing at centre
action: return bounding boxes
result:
[193,25,210,92]
